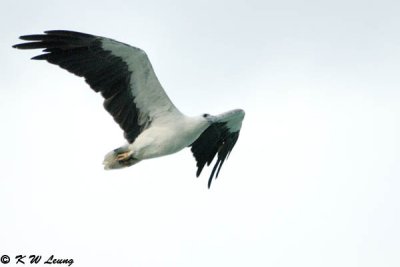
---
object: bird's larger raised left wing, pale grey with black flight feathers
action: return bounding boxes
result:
[13,31,180,143]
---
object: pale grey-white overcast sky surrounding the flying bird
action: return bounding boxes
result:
[0,0,400,267]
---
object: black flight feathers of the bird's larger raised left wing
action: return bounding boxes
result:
[12,30,143,143]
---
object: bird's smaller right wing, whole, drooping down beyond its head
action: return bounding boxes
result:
[191,109,244,188]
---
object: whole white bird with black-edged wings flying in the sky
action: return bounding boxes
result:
[13,30,245,188]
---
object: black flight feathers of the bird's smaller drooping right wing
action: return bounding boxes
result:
[191,122,240,189]
